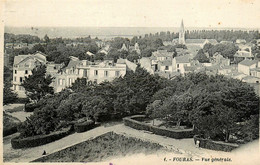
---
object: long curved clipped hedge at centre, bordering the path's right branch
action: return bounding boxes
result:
[123,115,194,139]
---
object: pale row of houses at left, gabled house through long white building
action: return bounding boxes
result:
[12,52,137,98]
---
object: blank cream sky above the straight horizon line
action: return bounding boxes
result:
[4,0,260,28]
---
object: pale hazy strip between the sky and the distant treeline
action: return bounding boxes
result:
[4,25,259,39]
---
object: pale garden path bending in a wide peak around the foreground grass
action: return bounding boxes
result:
[3,124,257,162]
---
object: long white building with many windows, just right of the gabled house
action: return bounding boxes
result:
[54,57,129,92]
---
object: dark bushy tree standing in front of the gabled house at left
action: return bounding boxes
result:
[21,65,54,103]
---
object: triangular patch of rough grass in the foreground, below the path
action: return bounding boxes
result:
[33,132,166,162]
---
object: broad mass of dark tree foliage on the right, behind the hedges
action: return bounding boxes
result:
[147,73,259,141]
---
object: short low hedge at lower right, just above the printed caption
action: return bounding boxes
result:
[193,135,239,152]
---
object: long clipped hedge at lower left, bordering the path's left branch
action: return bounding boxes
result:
[11,126,71,149]
